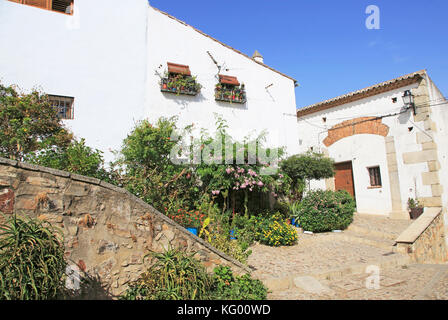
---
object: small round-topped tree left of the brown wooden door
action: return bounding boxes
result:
[280,152,334,199]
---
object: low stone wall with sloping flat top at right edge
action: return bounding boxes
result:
[396,208,448,263]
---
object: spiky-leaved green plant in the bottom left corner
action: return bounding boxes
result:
[0,215,66,300]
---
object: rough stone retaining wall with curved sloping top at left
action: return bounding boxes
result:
[0,158,250,295]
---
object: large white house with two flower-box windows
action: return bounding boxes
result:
[0,0,298,160]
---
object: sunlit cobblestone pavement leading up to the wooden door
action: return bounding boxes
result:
[248,215,448,300]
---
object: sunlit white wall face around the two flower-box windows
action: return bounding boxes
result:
[145,8,298,154]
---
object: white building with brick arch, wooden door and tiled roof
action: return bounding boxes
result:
[297,70,448,218]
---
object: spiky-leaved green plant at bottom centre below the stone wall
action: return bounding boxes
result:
[122,249,214,300]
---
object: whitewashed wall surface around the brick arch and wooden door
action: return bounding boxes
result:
[298,84,431,215]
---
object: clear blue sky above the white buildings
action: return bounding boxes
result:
[150,0,448,108]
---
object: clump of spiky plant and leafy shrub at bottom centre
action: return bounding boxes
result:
[121,249,267,300]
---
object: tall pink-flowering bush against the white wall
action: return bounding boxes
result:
[196,117,284,217]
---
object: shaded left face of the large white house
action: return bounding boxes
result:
[0,0,148,160]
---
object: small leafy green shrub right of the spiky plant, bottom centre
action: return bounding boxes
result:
[213,266,267,300]
